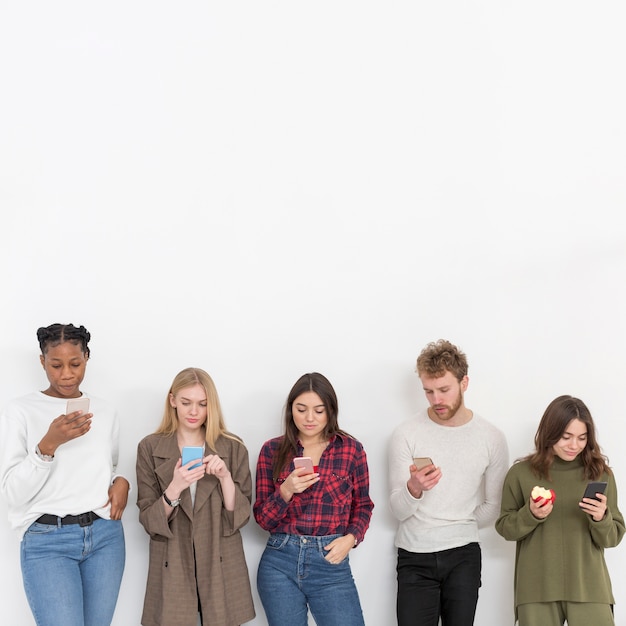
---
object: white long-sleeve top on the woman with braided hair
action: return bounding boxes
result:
[0,391,119,539]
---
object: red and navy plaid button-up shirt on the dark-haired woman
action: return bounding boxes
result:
[254,435,374,543]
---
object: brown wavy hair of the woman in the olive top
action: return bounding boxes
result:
[525,396,611,480]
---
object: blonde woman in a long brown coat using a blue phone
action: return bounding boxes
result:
[137,368,254,626]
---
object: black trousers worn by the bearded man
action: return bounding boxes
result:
[396,543,481,626]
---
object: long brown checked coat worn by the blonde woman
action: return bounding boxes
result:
[137,434,255,626]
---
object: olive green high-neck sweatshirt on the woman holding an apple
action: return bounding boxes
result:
[496,457,626,617]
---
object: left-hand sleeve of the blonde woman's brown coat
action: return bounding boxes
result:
[137,439,178,539]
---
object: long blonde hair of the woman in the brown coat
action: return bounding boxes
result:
[156,367,241,450]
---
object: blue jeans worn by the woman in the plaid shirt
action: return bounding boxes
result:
[257,533,365,626]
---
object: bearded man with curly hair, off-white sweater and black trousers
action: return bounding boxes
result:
[389,339,509,626]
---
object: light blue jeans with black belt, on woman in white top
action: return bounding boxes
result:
[20,519,125,626]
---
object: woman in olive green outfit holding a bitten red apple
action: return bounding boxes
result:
[496,396,626,626]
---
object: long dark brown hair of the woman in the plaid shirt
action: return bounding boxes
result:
[272,372,350,480]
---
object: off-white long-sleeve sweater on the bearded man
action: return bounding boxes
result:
[389,410,509,553]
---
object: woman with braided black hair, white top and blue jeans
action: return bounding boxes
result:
[0,324,129,626]
